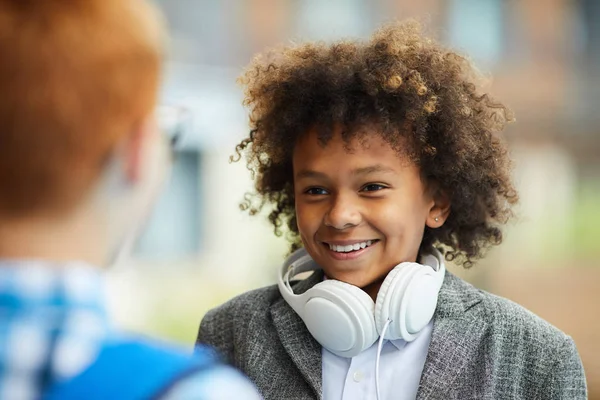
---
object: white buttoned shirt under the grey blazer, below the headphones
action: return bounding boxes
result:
[322,322,433,400]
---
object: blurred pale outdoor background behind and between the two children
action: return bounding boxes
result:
[109,0,600,399]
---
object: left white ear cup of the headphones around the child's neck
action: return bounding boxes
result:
[301,280,378,357]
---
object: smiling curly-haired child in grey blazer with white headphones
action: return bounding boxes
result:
[198,22,586,399]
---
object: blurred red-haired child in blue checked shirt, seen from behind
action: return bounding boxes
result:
[0,0,258,400]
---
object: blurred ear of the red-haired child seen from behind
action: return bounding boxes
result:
[123,117,154,184]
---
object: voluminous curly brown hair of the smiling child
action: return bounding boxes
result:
[232,21,518,268]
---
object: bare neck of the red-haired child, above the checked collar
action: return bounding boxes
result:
[0,207,107,266]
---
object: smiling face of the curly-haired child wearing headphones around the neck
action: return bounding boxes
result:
[293,126,449,298]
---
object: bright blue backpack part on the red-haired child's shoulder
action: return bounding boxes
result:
[42,341,216,400]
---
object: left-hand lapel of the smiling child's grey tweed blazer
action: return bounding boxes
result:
[271,271,323,398]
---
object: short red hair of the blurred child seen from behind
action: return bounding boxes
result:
[0,0,162,216]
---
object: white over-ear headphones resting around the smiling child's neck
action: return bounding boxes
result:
[278,249,446,357]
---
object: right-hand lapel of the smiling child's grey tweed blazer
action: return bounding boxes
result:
[417,273,486,400]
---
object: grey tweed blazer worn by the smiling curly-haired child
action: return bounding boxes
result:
[197,272,587,400]
